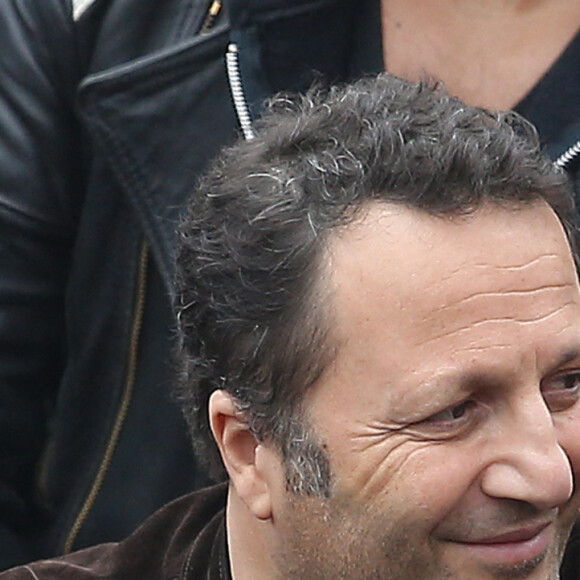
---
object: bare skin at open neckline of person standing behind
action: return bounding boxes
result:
[381,0,580,109]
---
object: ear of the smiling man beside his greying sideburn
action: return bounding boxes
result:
[209,390,274,520]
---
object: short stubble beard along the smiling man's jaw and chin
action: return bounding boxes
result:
[274,494,564,580]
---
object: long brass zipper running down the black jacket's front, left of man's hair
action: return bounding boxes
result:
[64,241,149,554]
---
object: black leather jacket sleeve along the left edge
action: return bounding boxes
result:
[0,0,82,569]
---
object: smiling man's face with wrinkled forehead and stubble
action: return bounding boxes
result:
[273,203,580,580]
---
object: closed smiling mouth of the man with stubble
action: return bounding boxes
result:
[457,523,554,566]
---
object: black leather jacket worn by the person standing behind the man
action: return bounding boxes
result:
[0,0,580,568]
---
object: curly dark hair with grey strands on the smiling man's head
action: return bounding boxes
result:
[177,74,573,484]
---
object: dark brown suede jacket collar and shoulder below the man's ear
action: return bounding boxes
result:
[0,484,231,580]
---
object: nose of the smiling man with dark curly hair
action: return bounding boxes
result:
[481,400,574,510]
